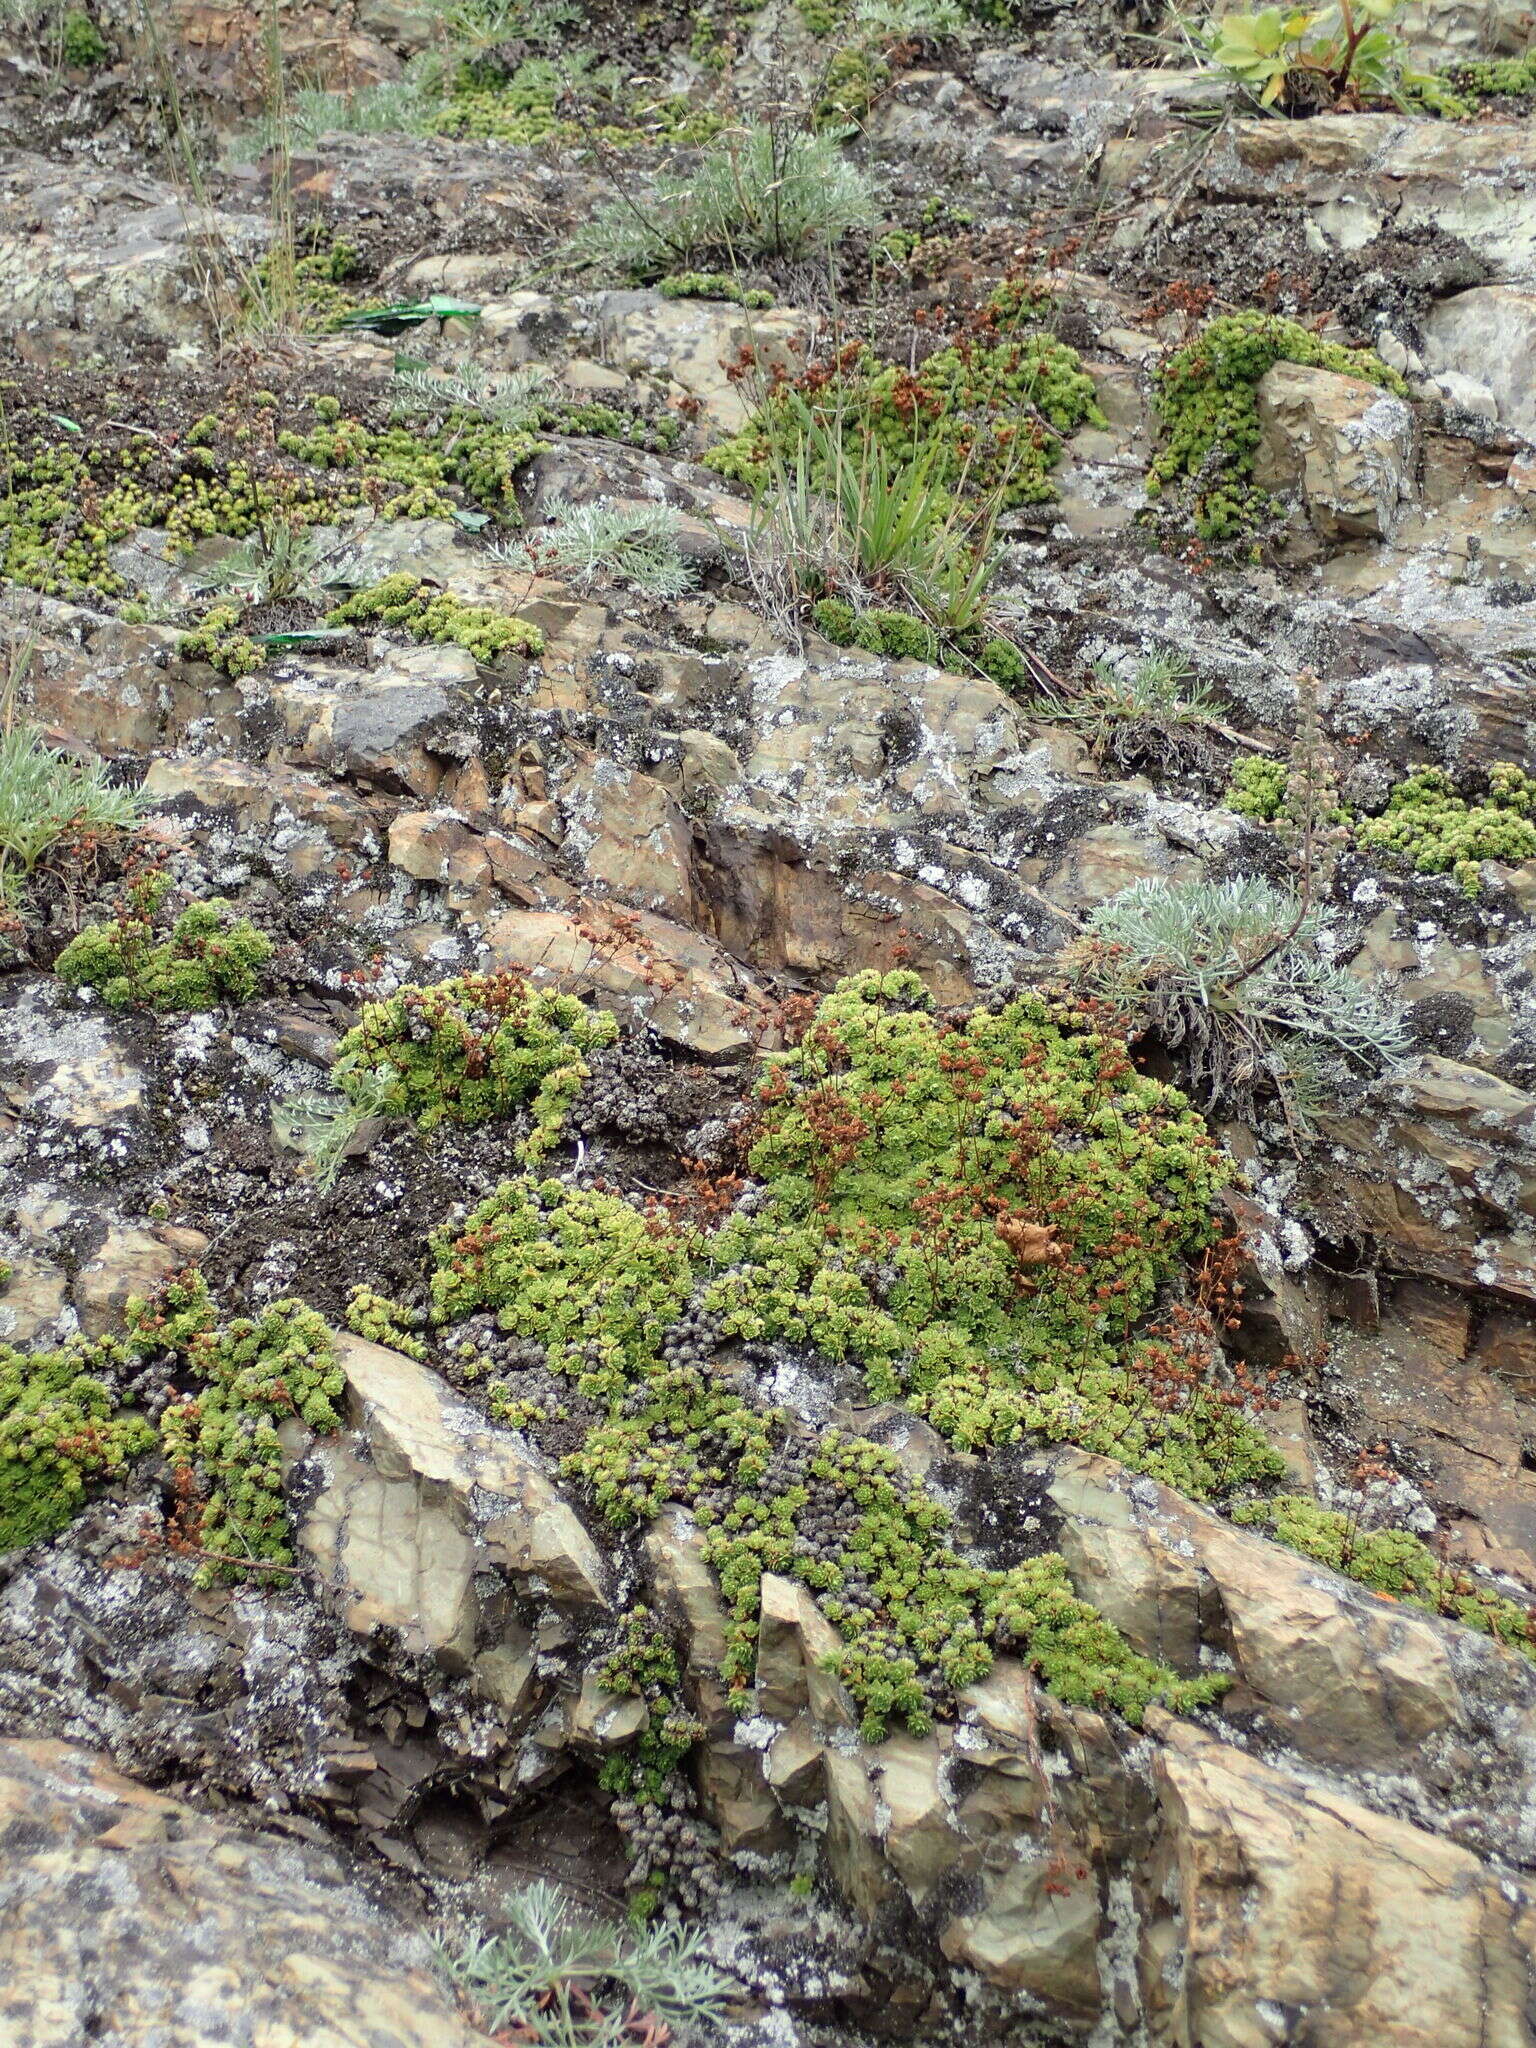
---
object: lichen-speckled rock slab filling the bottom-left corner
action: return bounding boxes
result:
[0,1741,481,2048]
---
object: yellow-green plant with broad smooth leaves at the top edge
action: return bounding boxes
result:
[1198,0,1407,113]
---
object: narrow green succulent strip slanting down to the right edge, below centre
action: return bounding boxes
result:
[1233,1493,1536,1659]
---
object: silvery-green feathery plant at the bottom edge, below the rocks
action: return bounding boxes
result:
[436,1880,731,2048]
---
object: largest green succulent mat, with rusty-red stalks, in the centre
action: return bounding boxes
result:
[352,973,1280,1739]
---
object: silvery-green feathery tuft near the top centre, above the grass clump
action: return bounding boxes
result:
[571,125,874,283]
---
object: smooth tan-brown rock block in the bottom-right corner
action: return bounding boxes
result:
[1143,1710,1536,2048]
